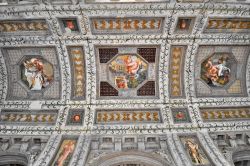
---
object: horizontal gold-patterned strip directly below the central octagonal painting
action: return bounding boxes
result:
[95,109,162,124]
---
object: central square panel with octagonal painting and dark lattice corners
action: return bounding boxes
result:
[96,46,159,98]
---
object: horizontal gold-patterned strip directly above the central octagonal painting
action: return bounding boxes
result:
[91,17,164,34]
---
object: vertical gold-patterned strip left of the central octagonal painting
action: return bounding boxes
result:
[68,46,86,99]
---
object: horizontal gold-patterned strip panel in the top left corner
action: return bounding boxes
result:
[0,20,48,35]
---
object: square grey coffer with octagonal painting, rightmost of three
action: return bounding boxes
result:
[194,45,250,97]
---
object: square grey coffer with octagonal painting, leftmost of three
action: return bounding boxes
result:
[3,47,61,100]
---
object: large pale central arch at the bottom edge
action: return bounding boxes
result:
[91,151,173,166]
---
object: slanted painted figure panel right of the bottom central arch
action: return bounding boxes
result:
[180,136,210,166]
